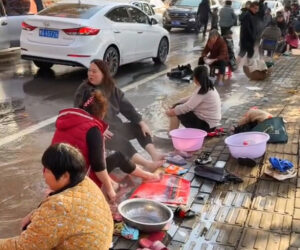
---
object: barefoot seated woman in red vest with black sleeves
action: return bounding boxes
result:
[52,90,159,201]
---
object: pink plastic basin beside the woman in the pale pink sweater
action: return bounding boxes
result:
[170,128,207,152]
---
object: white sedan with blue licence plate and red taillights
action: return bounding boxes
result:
[21,1,170,75]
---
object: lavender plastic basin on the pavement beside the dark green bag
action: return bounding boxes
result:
[225,132,270,159]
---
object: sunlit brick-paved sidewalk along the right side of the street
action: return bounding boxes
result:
[114,57,300,250]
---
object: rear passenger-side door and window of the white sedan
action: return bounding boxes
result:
[106,6,138,64]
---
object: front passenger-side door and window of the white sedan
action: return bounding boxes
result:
[128,7,160,59]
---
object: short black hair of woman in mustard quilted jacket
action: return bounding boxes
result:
[42,143,86,189]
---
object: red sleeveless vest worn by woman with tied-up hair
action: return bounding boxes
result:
[51,108,108,187]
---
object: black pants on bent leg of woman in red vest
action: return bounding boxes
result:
[106,152,136,174]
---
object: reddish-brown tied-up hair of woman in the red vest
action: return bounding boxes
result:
[79,90,108,119]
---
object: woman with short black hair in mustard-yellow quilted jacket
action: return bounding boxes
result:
[0,143,113,250]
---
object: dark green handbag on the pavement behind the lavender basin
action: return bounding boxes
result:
[251,117,288,143]
